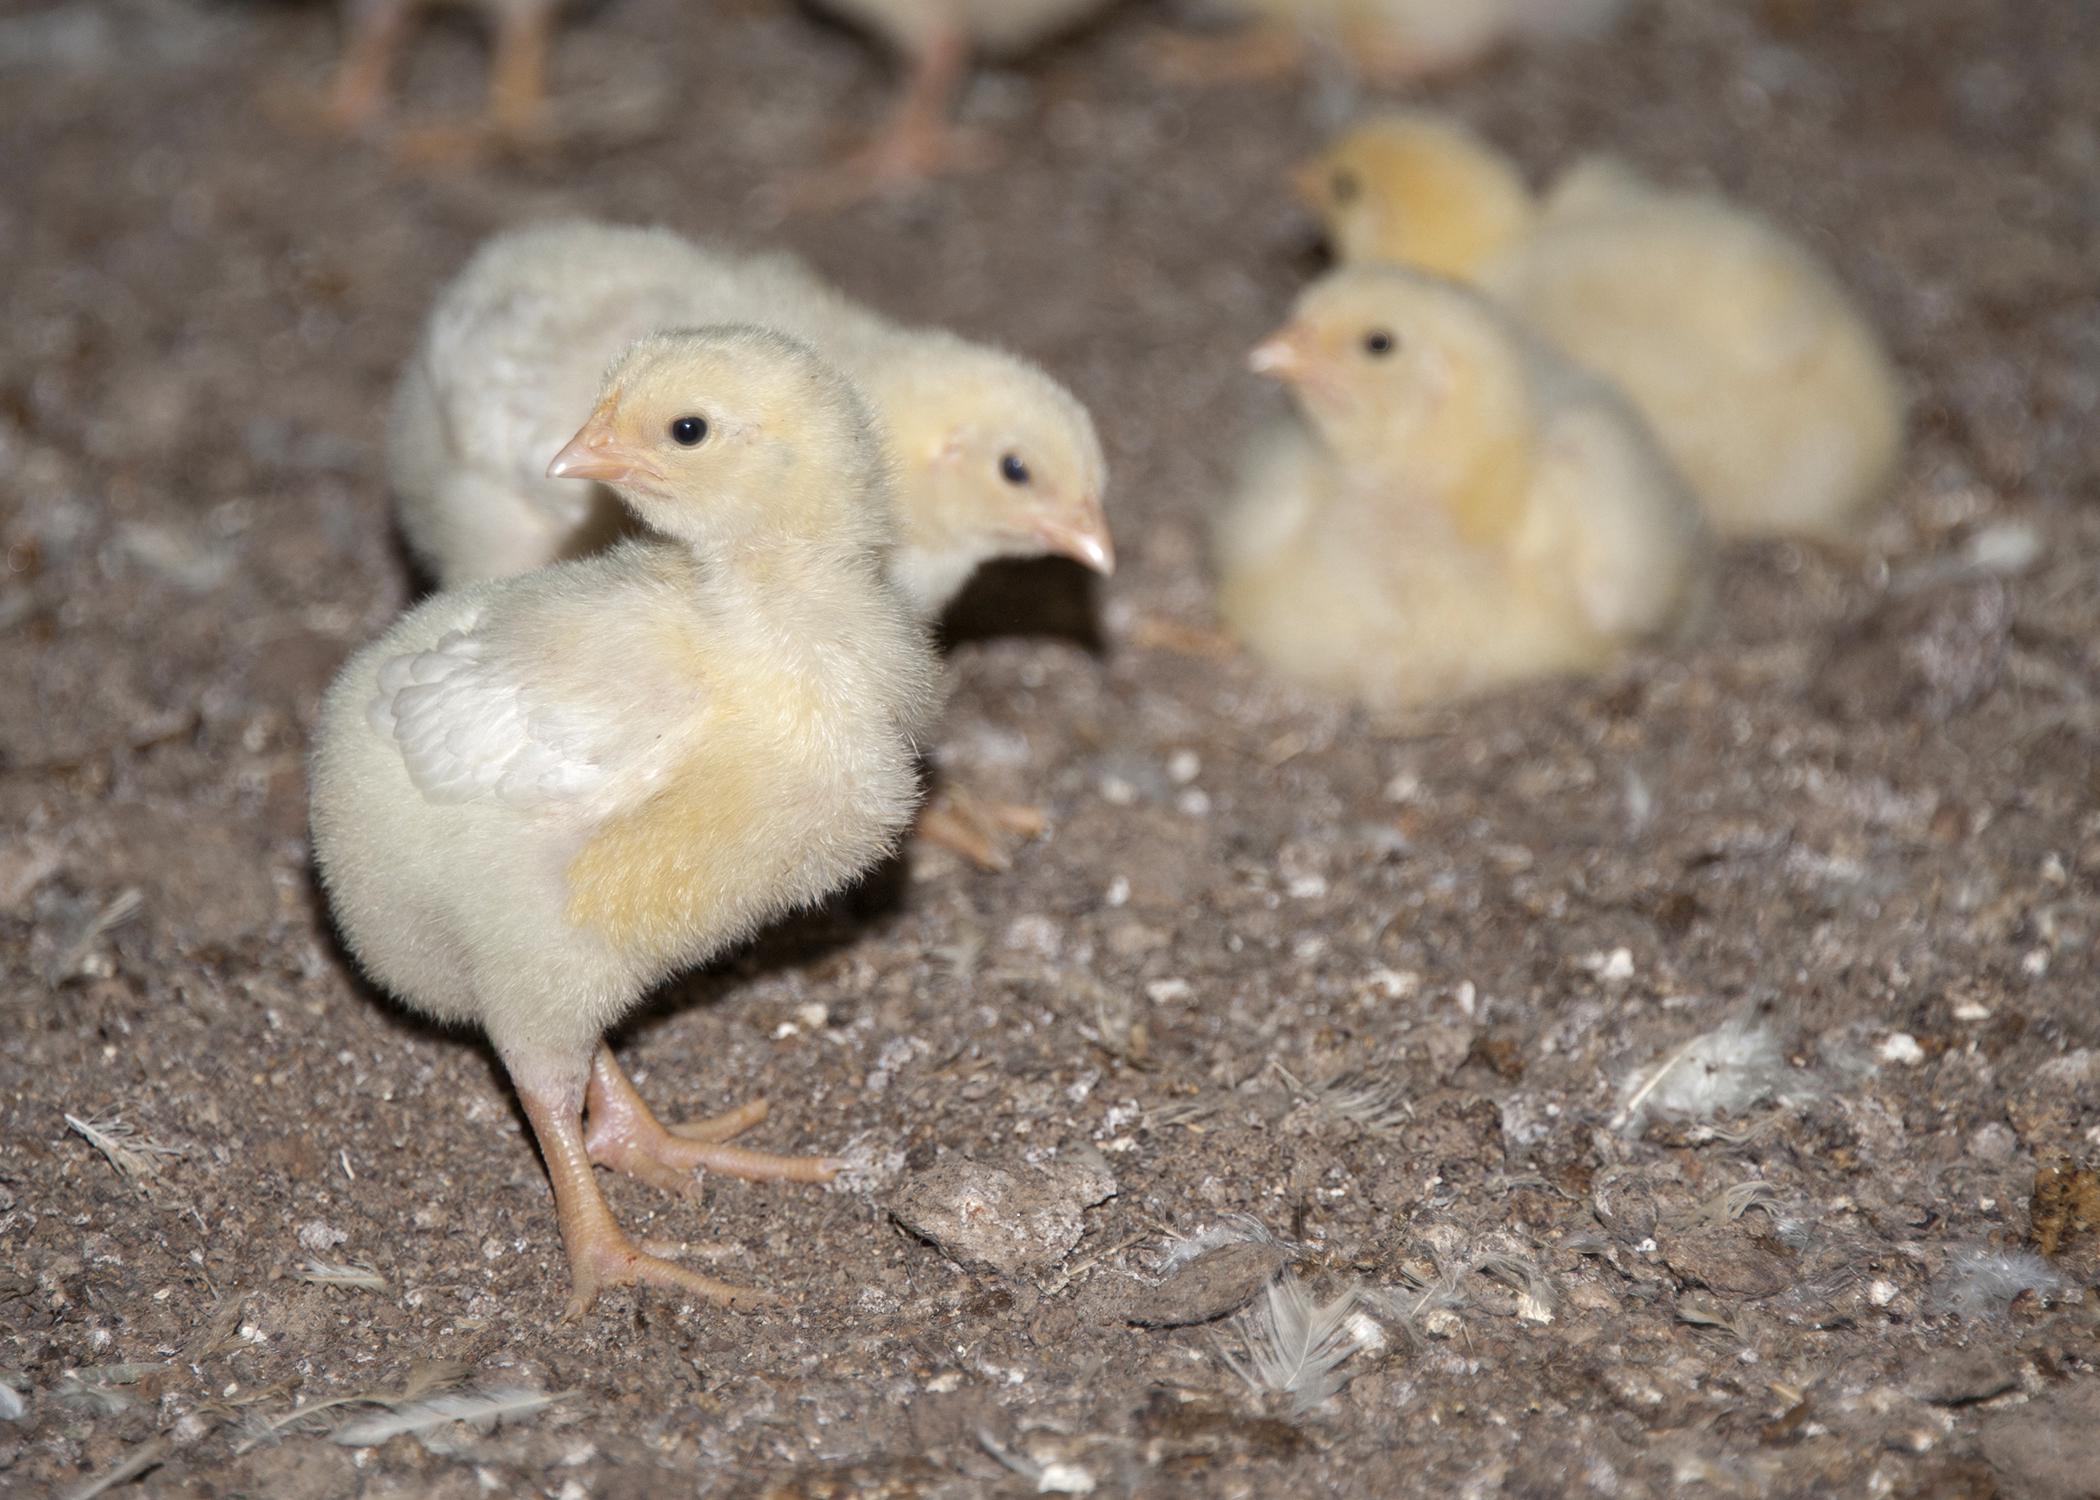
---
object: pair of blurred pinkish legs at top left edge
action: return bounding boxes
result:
[326,0,561,153]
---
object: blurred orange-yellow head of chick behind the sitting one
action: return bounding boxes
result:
[1294,113,1533,277]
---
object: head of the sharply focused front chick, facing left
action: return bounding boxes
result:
[546,326,888,546]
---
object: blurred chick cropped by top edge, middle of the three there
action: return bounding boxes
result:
[809,0,1111,197]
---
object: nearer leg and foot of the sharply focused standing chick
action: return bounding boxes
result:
[506,1059,777,1324]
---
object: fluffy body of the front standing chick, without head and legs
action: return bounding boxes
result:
[313,544,930,1048]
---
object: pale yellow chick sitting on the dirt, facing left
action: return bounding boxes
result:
[1218,267,1707,708]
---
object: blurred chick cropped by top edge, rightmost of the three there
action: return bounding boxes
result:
[1161,0,1628,84]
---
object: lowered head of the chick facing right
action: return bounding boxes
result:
[872,336,1115,607]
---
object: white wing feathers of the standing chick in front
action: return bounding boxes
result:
[365,628,609,807]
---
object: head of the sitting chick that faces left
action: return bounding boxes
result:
[1247,267,1533,540]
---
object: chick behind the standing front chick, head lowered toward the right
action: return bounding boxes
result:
[389,221,1115,870]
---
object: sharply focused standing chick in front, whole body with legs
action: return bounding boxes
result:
[313,328,937,1317]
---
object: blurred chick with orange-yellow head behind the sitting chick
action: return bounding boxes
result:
[1298,116,1905,536]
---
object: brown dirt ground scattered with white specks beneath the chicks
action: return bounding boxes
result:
[0,0,2100,1500]
